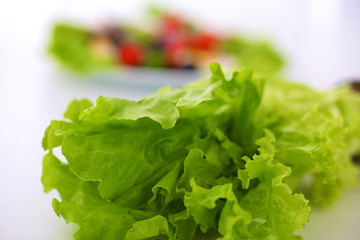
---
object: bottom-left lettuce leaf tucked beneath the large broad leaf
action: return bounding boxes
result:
[42,153,152,240]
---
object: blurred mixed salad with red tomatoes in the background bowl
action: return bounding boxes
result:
[49,9,284,73]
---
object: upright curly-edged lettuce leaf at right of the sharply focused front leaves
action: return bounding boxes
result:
[239,130,310,240]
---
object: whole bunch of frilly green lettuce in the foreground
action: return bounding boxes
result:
[42,63,360,240]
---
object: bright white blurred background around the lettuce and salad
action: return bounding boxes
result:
[0,0,360,240]
